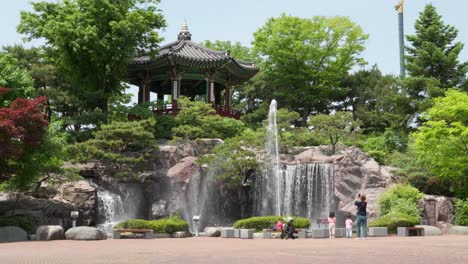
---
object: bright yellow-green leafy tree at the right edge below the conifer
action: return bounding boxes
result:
[411,89,468,198]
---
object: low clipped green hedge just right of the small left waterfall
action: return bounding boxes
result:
[114,216,188,234]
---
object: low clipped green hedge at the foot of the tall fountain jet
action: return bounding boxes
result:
[233,216,310,231]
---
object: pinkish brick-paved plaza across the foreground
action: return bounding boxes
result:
[0,235,468,264]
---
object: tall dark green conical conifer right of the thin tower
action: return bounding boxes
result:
[406,4,468,88]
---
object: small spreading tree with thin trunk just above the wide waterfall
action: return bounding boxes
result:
[308,111,359,154]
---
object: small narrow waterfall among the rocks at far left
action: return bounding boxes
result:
[97,188,124,232]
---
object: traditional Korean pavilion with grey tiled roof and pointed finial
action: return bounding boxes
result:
[128,23,259,118]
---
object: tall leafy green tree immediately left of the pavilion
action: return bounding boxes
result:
[18,0,165,121]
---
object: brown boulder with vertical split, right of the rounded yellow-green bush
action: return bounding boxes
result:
[420,195,455,226]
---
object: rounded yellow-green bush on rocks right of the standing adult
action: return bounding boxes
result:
[378,184,424,217]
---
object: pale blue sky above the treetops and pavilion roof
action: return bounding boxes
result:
[0,0,468,75]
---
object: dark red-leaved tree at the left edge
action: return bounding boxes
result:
[0,87,48,182]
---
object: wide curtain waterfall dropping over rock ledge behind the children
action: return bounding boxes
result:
[255,163,336,221]
